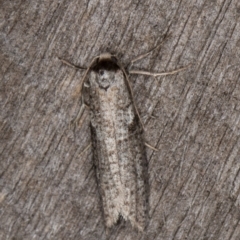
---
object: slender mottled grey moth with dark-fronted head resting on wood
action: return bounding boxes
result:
[60,46,188,231]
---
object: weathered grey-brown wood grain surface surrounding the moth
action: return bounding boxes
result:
[0,0,240,240]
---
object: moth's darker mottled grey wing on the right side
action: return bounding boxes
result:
[115,101,148,230]
